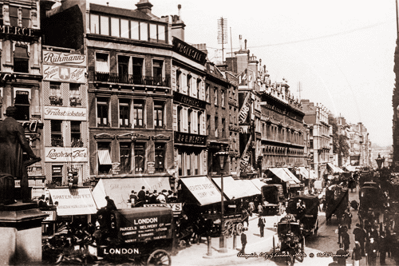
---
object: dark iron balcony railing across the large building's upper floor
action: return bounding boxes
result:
[93,72,170,87]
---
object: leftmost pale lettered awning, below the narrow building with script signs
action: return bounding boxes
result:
[49,188,97,216]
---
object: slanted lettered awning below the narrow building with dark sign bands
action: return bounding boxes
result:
[180,176,224,206]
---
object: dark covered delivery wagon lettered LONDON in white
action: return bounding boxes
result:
[94,207,175,265]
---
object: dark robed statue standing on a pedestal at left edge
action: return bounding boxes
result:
[0,106,41,202]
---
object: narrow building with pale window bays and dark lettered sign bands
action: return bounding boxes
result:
[172,37,208,178]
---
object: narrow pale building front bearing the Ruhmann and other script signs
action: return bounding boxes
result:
[42,45,90,186]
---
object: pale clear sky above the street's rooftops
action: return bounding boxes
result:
[91,0,397,146]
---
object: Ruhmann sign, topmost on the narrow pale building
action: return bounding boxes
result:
[43,51,86,66]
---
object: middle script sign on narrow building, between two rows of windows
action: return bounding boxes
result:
[44,106,87,121]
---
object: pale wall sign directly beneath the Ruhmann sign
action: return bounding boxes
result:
[43,65,86,83]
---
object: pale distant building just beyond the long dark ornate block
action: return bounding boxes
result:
[301,100,336,178]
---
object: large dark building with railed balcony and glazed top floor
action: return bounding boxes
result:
[44,0,175,190]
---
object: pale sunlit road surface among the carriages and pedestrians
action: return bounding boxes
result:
[172,186,396,266]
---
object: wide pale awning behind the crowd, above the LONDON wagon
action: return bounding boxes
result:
[93,177,170,209]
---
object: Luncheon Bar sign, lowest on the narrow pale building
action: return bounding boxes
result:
[44,147,88,163]
